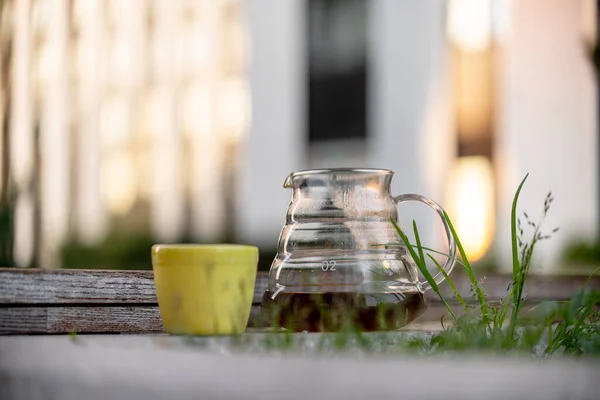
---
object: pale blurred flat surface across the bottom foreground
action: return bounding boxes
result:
[0,334,600,400]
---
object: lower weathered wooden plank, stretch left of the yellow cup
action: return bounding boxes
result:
[0,306,164,334]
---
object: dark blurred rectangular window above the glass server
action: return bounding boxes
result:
[307,0,368,142]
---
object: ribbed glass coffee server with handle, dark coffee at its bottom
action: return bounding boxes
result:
[261,169,456,332]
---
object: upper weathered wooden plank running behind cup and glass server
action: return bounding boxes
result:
[0,268,600,307]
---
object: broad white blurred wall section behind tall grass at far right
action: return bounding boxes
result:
[496,0,598,270]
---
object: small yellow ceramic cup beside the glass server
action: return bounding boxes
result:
[152,244,258,335]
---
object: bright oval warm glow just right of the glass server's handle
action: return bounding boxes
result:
[446,156,495,261]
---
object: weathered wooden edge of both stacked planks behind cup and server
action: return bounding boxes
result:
[0,268,600,335]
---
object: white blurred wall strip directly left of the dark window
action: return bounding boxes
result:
[236,0,308,248]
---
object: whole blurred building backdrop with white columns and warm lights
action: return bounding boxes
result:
[0,0,600,271]
